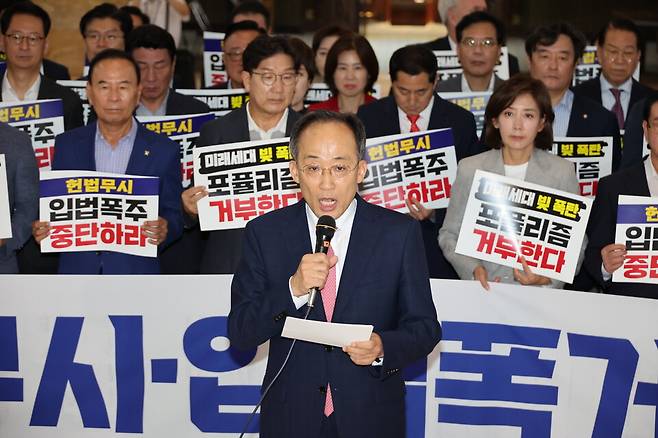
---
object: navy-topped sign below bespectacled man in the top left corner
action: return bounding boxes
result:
[0,99,64,171]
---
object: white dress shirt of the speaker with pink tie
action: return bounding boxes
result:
[289,199,356,309]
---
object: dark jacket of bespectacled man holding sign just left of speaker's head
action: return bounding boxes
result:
[198,106,301,274]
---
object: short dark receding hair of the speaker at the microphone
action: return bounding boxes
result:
[290,110,366,160]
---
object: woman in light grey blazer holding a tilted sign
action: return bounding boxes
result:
[439,74,580,290]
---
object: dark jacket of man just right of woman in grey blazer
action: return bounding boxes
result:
[567,93,621,172]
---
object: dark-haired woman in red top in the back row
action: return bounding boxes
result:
[308,35,379,114]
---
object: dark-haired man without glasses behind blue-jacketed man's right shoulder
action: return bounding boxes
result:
[126,24,210,116]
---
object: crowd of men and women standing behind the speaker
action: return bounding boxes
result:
[0,0,658,297]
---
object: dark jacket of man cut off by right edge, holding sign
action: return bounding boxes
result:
[585,161,658,298]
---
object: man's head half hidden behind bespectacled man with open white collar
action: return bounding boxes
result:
[211,20,265,89]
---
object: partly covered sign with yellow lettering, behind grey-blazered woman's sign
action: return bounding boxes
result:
[551,137,613,198]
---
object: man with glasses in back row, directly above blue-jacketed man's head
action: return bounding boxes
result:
[80,3,132,69]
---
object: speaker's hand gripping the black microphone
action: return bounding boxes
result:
[291,216,338,307]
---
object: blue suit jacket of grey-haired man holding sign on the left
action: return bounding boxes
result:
[52,120,183,274]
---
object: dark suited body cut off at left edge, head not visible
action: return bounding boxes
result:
[0,123,39,274]
